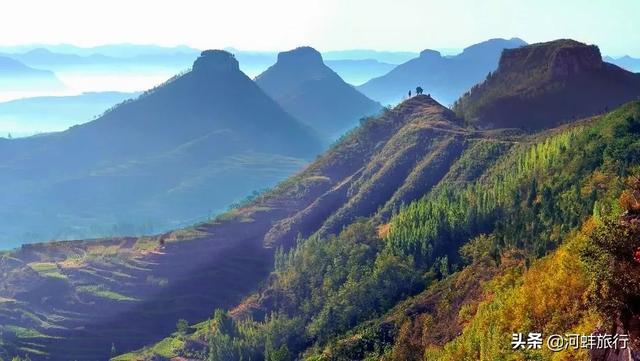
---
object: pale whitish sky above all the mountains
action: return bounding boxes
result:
[0,0,640,57]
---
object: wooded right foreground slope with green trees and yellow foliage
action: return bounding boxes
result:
[130,102,640,361]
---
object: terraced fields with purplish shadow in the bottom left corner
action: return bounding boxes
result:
[0,224,271,360]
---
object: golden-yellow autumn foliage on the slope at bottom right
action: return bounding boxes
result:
[424,233,599,361]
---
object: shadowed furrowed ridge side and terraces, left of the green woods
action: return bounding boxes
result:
[0,96,502,360]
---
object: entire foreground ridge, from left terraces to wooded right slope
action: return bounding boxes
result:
[1,97,640,360]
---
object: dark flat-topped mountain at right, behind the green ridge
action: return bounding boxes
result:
[454,40,640,129]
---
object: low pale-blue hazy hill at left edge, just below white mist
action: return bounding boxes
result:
[0,92,139,137]
